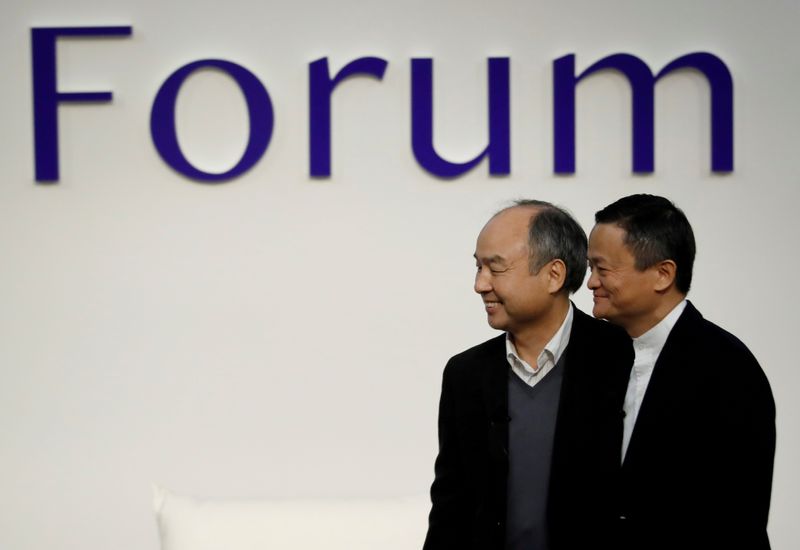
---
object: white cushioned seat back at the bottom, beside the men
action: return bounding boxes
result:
[153,485,430,550]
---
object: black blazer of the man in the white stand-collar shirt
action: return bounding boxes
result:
[618,303,775,550]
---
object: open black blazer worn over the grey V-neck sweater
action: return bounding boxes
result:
[424,306,633,550]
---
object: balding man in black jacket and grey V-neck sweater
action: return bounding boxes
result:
[424,201,632,550]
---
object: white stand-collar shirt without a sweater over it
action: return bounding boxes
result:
[622,299,686,461]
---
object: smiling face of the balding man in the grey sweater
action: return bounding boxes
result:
[475,207,550,334]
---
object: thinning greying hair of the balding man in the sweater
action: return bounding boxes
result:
[509,199,588,294]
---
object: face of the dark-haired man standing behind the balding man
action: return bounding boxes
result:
[586,223,659,337]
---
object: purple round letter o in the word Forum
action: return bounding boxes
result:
[150,59,274,183]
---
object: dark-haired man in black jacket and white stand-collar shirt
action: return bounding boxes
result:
[588,195,775,550]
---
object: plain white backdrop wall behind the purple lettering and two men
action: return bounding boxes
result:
[0,0,800,550]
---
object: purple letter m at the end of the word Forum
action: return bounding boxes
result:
[553,52,733,174]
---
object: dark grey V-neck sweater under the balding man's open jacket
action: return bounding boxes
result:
[506,353,566,550]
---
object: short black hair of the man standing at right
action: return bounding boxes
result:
[594,194,696,294]
